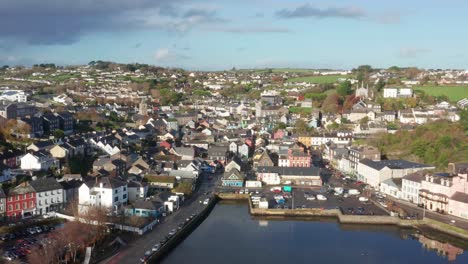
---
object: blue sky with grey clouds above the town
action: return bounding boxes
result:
[0,0,468,70]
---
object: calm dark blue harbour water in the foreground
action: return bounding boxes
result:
[162,203,468,264]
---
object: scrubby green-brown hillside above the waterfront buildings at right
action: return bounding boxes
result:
[367,121,468,170]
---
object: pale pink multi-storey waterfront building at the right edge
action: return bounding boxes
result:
[419,170,468,219]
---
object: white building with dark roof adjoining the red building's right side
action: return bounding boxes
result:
[29,178,64,215]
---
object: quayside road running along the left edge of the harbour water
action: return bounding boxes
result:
[101,171,221,264]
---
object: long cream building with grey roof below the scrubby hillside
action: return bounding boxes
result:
[357,159,435,188]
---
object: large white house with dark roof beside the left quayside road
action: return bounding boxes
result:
[78,177,128,212]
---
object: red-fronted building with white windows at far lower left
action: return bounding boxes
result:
[6,183,36,219]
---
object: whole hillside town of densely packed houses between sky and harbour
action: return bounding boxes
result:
[0,61,468,263]
